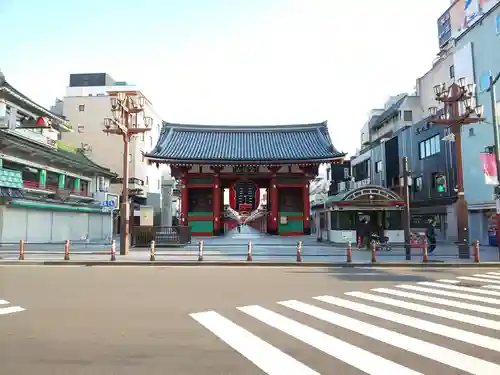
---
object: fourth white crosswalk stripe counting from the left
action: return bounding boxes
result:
[312,296,500,352]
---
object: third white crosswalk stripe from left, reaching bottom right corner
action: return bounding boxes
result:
[281,301,500,375]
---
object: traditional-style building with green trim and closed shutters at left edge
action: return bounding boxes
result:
[0,74,115,244]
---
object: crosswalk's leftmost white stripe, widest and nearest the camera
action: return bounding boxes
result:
[190,311,320,375]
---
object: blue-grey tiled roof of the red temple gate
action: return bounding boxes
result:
[145,122,345,163]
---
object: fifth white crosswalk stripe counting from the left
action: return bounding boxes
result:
[345,292,500,331]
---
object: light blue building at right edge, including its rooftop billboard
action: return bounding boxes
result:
[438,0,500,245]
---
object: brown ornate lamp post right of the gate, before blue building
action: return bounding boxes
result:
[429,78,483,259]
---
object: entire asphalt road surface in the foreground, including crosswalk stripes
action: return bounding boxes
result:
[0,266,500,375]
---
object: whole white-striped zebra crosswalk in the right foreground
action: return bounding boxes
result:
[190,272,500,375]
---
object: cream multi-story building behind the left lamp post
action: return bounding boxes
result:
[55,73,173,226]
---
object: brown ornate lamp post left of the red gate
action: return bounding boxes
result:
[103,92,153,255]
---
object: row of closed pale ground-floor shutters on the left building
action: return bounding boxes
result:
[0,206,112,243]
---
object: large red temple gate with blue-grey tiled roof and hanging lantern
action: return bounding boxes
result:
[146,122,345,236]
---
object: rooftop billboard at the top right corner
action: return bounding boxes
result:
[438,0,500,47]
